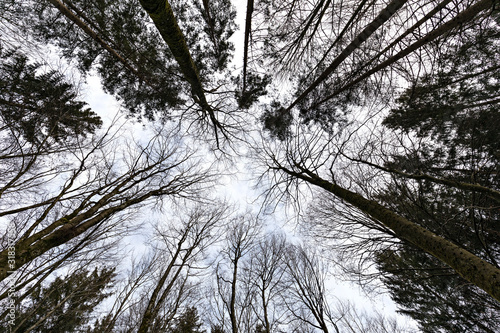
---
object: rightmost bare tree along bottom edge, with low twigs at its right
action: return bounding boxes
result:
[281,241,409,333]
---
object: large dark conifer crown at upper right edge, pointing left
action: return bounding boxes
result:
[384,14,500,166]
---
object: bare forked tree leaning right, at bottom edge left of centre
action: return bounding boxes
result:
[138,203,228,332]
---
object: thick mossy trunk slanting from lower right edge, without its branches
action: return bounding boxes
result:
[282,169,500,301]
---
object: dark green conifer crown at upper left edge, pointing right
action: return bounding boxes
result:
[0,49,102,144]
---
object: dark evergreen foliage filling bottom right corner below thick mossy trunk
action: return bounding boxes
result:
[377,244,500,333]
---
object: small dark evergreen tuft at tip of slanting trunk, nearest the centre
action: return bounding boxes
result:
[260,101,293,141]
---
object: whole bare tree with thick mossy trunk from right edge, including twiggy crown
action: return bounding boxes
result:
[256,119,500,300]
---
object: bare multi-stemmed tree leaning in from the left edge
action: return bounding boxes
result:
[0,120,210,280]
